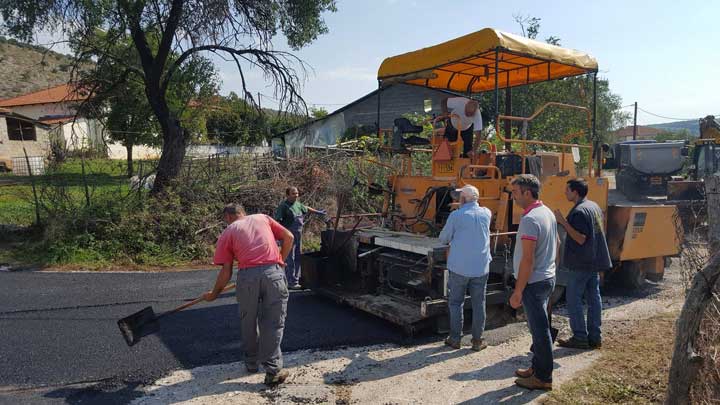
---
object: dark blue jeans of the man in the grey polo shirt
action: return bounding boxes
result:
[522,277,555,382]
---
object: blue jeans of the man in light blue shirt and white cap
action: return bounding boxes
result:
[448,271,488,342]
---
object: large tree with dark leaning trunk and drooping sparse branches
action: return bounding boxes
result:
[0,0,335,192]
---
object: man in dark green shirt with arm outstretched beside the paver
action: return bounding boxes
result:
[275,187,326,290]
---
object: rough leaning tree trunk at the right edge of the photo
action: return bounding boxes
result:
[665,176,720,405]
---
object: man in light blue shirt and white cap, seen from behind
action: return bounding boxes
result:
[440,185,492,351]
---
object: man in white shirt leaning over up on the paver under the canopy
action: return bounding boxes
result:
[440,97,482,157]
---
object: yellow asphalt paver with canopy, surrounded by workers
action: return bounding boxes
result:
[303,29,681,331]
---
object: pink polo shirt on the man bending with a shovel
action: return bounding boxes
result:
[213,214,286,269]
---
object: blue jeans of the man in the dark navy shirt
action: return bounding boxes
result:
[565,271,602,342]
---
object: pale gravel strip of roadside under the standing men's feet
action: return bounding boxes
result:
[133,265,682,404]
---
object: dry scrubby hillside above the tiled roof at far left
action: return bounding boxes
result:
[0,37,72,100]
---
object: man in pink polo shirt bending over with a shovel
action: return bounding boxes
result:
[204,204,293,385]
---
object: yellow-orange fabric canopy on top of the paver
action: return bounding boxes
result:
[378,28,598,93]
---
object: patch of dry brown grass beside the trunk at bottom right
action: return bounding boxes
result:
[544,313,678,404]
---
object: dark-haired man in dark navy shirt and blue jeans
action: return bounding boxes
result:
[555,178,612,349]
